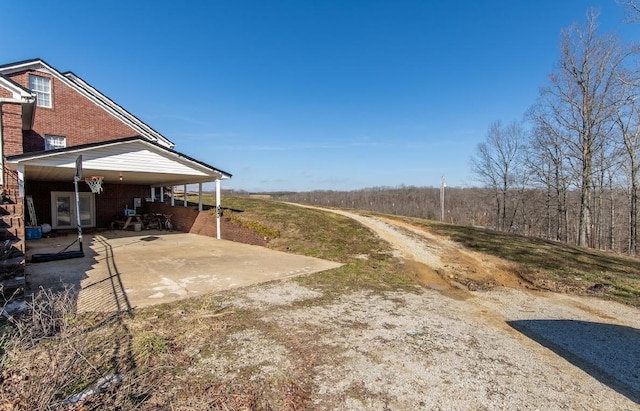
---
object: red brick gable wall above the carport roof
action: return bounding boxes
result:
[5,70,138,155]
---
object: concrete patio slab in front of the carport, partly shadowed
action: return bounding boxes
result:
[26,230,340,312]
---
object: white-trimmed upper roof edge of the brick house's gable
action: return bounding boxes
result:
[0,59,175,148]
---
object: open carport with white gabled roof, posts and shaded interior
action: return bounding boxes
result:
[6,136,231,237]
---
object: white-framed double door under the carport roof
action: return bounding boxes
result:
[51,191,96,228]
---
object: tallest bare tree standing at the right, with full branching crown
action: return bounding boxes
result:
[540,11,626,247]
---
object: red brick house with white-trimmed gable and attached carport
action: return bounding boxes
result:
[0,59,231,292]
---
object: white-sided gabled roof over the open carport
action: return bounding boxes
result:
[6,136,231,186]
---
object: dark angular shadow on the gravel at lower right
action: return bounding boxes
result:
[507,320,640,403]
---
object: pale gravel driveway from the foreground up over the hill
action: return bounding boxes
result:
[208,212,640,410]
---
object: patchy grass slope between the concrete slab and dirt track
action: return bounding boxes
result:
[223,197,414,291]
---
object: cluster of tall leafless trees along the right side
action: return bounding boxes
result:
[471,7,640,255]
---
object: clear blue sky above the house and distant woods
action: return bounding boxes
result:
[0,0,640,191]
